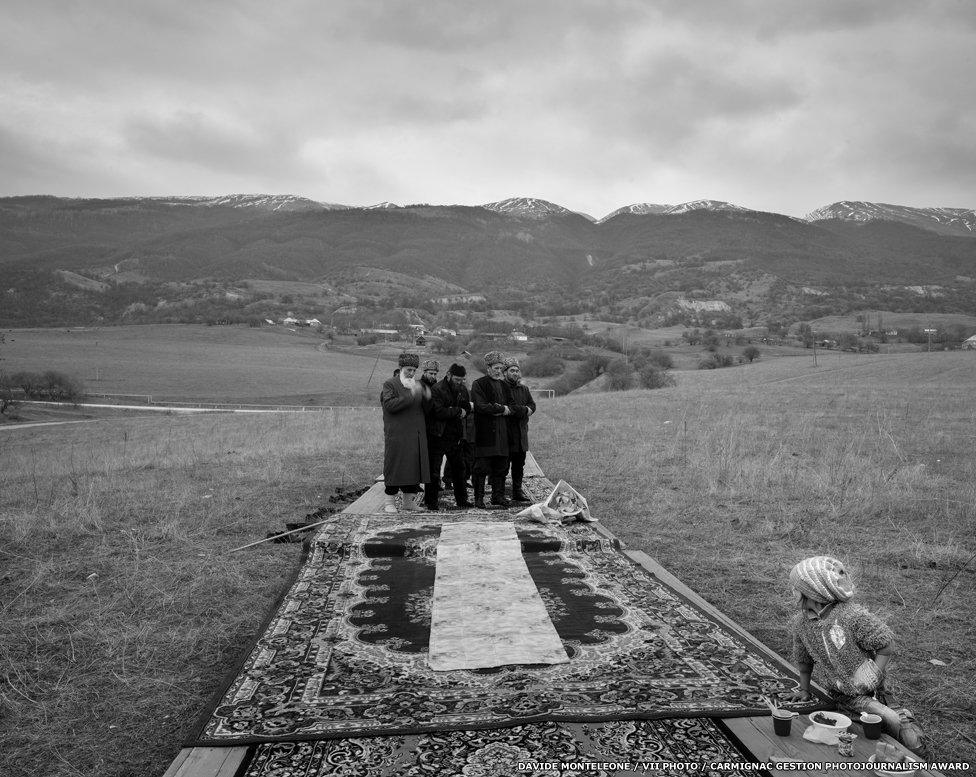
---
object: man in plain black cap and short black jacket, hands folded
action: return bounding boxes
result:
[424,364,473,510]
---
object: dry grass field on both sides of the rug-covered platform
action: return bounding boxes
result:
[0,352,976,777]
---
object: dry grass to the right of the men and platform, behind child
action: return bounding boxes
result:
[532,353,976,762]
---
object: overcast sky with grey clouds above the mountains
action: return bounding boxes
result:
[0,0,976,217]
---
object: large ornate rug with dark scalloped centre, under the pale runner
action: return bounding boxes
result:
[190,504,816,745]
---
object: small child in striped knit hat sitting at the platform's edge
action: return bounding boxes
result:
[790,556,924,751]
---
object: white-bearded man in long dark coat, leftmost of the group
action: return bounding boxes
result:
[380,353,430,513]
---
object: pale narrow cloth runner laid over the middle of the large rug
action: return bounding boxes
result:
[427,522,569,671]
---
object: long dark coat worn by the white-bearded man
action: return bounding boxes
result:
[380,377,430,486]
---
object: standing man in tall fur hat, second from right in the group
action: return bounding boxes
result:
[471,351,512,510]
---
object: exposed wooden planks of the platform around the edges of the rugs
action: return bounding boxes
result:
[163,453,942,777]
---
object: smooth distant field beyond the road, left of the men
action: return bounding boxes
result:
[4,324,396,405]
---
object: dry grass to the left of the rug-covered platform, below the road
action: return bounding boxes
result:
[0,410,380,777]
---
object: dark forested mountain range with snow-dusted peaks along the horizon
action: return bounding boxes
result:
[0,194,976,325]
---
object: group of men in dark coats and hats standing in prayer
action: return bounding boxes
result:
[380,351,536,513]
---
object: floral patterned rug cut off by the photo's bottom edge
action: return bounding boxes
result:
[237,718,768,777]
